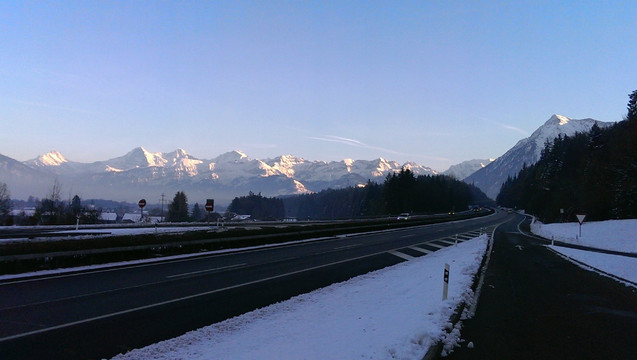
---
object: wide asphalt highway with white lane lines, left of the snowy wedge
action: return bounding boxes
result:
[0,212,512,359]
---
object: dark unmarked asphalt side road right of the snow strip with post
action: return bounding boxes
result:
[446,215,637,360]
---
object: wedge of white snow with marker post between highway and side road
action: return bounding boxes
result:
[110,235,488,360]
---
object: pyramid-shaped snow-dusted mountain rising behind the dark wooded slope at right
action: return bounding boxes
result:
[464,115,613,199]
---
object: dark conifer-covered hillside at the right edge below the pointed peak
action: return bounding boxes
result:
[497,90,637,222]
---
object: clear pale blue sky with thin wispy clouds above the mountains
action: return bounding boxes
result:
[0,1,637,170]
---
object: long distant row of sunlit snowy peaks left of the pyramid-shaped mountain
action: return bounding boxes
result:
[0,147,436,204]
